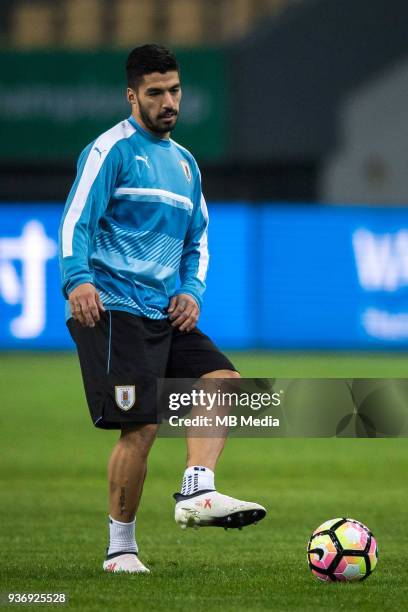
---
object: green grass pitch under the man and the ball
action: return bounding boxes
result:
[0,353,408,612]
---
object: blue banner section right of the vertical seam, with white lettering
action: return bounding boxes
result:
[255,206,408,349]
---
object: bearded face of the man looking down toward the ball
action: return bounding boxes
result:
[127,70,181,135]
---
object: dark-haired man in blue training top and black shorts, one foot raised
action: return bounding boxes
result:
[60,45,266,573]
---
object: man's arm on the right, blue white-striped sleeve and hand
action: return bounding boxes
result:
[168,173,209,332]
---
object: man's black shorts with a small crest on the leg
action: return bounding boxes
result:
[67,310,235,429]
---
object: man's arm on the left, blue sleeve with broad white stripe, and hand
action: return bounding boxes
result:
[59,144,121,327]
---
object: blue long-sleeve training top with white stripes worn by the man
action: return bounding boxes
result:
[59,117,208,319]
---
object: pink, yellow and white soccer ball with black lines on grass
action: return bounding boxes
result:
[307,518,378,582]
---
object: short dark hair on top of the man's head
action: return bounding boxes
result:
[126,44,180,88]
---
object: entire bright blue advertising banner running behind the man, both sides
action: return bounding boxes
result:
[0,203,408,349]
